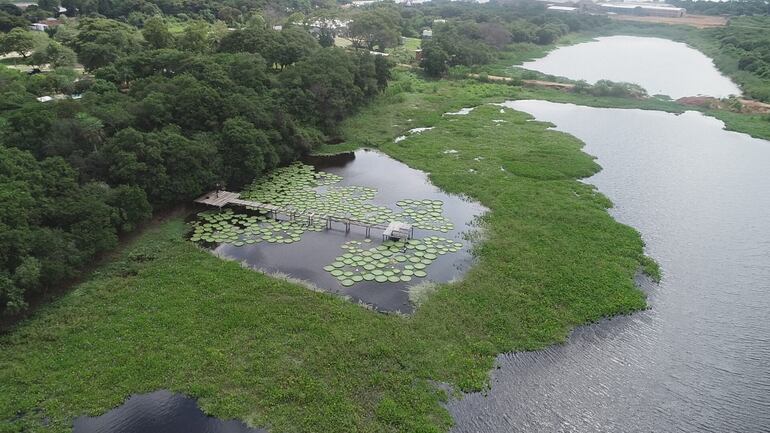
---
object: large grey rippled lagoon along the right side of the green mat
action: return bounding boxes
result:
[449,101,770,433]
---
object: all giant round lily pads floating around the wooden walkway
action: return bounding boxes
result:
[190,163,463,286]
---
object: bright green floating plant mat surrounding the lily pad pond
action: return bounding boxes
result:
[0,71,656,433]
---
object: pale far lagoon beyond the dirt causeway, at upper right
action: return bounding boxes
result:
[521,36,741,99]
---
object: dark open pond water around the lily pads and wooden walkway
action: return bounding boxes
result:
[204,150,485,313]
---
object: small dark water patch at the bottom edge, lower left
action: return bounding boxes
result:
[73,390,267,433]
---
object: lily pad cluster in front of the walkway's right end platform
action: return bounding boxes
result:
[324,236,463,287]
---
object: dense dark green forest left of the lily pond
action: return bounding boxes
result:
[0,3,390,314]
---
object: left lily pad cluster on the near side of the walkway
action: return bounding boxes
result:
[190,209,324,247]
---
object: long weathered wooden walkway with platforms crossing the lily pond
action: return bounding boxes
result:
[195,191,414,239]
